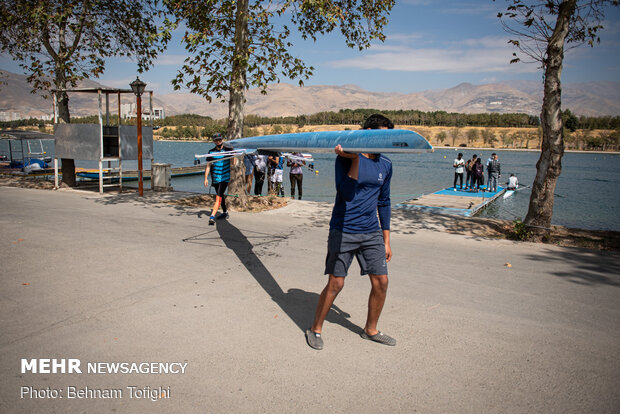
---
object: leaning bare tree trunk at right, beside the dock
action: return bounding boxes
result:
[524,0,576,240]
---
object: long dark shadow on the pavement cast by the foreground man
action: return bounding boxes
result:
[216,220,362,333]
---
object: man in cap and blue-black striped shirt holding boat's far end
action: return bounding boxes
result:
[205,134,236,226]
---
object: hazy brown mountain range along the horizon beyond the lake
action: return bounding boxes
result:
[0,70,620,119]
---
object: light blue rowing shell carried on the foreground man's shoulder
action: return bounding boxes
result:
[226,129,433,153]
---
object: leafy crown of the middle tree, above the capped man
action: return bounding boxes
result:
[164,0,394,101]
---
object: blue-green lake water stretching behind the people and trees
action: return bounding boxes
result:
[0,141,620,231]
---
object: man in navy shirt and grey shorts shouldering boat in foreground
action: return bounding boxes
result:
[306,114,396,349]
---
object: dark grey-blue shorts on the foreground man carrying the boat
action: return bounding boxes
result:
[325,230,387,277]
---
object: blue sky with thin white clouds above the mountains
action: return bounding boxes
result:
[0,0,620,94]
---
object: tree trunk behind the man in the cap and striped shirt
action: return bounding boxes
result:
[226,0,249,209]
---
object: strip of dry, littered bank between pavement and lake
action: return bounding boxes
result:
[0,175,620,251]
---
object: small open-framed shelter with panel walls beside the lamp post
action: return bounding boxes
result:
[53,88,153,194]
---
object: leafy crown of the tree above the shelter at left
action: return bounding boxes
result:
[0,0,170,97]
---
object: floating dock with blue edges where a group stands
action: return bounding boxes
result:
[396,186,506,217]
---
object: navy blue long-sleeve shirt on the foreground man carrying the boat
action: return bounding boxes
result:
[329,155,392,233]
